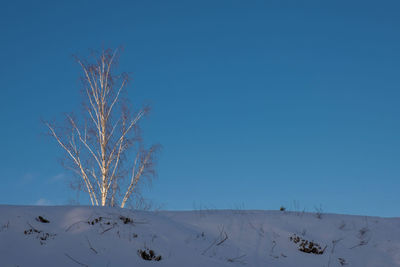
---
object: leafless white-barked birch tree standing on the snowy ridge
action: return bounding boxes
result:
[45,49,159,208]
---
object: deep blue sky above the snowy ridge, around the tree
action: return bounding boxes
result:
[0,0,400,216]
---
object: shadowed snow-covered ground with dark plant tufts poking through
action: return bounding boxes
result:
[0,206,400,267]
